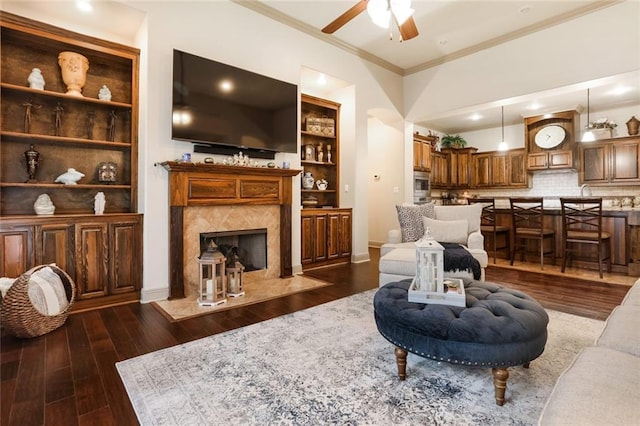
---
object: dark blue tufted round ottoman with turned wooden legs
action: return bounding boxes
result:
[373,280,549,405]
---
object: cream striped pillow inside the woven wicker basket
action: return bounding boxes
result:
[27,266,69,316]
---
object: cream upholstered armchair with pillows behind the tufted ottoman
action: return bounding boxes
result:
[378,203,489,287]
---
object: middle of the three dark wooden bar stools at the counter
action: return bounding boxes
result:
[509,197,556,269]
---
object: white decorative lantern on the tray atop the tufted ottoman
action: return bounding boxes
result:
[415,238,444,293]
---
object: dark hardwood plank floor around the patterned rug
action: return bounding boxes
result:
[0,249,629,426]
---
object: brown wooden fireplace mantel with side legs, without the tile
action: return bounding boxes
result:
[162,161,302,299]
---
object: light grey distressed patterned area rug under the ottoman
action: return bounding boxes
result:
[117,290,604,425]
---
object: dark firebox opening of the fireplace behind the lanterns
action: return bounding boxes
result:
[200,228,267,272]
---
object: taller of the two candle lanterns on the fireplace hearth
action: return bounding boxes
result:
[198,240,227,306]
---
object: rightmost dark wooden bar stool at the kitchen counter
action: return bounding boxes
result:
[560,197,611,278]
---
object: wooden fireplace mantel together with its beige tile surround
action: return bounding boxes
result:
[162,161,301,299]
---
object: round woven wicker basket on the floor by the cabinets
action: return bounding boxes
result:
[2,265,76,337]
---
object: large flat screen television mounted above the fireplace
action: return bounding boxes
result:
[171,49,298,158]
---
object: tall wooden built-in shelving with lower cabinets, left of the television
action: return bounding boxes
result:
[0,12,142,309]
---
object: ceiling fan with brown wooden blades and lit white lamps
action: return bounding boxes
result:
[322,0,418,41]
